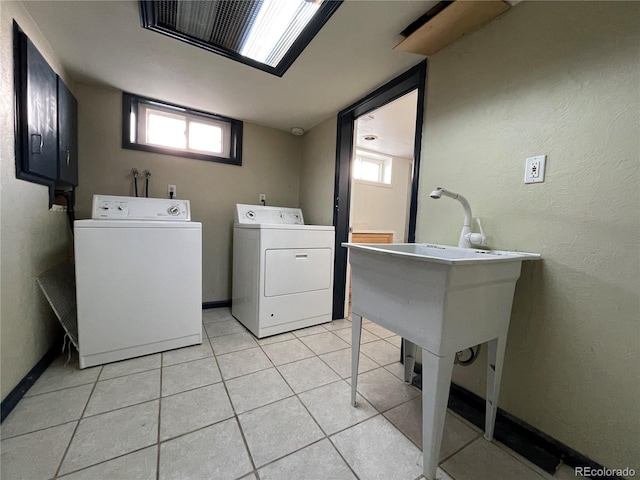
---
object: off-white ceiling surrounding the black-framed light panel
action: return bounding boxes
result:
[23,0,436,130]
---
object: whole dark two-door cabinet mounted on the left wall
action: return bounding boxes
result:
[13,22,78,199]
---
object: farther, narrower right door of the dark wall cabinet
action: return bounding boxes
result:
[58,77,78,185]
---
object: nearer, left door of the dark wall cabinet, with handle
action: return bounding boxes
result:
[23,39,58,180]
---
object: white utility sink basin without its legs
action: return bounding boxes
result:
[343,243,540,355]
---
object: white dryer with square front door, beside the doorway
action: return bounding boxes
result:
[231,204,335,338]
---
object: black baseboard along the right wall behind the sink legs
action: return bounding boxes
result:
[413,364,624,480]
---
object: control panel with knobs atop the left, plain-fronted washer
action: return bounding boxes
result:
[91,195,191,222]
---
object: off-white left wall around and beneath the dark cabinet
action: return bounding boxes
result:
[0,1,71,400]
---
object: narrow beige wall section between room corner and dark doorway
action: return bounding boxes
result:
[300,116,338,225]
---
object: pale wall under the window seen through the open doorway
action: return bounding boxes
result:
[351,157,413,242]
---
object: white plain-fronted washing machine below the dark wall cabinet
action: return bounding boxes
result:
[74,195,202,368]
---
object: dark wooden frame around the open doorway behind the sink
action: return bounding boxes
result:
[332,60,427,319]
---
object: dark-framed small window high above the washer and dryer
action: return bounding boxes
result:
[122,93,242,165]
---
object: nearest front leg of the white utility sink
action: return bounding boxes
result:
[422,349,455,480]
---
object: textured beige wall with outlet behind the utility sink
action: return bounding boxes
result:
[418,2,640,471]
